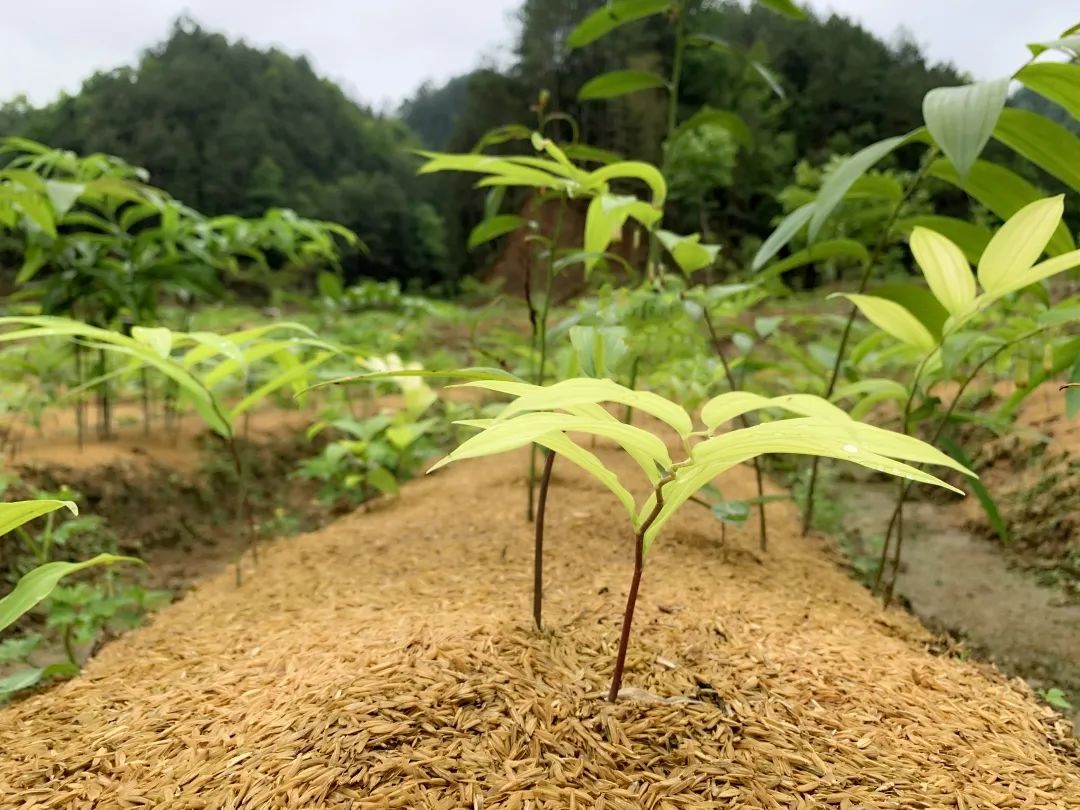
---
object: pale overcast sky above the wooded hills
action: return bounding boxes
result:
[0,0,1080,108]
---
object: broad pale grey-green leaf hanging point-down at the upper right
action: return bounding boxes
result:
[922,79,1009,177]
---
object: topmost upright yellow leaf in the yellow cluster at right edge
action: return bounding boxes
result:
[978,195,1065,296]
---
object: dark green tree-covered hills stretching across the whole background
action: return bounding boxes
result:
[0,0,961,287]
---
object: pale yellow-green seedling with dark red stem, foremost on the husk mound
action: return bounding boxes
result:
[429,378,974,701]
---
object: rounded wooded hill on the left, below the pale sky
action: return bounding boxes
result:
[0,19,446,284]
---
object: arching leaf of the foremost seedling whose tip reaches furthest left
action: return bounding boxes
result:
[429,413,672,472]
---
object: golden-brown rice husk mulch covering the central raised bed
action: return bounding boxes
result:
[0,448,1080,810]
